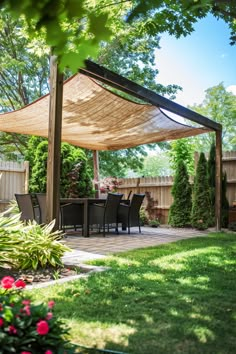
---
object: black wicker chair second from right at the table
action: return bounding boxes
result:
[89,193,123,236]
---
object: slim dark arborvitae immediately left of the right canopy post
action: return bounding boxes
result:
[207,143,216,226]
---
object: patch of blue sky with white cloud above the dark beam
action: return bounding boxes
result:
[156,16,236,106]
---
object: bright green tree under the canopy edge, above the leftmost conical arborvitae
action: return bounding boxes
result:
[169,138,194,175]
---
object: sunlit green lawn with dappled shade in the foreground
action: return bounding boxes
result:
[28,233,236,354]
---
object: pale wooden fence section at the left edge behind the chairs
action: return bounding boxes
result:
[0,161,29,211]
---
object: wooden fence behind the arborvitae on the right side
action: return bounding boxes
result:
[119,151,236,224]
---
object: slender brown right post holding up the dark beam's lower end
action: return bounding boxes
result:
[215,131,222,231]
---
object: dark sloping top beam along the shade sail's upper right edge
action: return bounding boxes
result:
[79,60,222,131]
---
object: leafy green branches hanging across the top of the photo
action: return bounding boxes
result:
[0,0,236,71]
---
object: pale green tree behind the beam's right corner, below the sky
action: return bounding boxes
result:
[189,83,236,152]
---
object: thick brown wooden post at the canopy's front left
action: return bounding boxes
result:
[46,55,63,230]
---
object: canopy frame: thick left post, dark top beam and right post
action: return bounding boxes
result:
[47,56,222,230]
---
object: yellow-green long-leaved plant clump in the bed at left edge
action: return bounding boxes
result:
[0,209,70,270]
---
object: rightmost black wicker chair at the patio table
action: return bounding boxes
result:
[118,194,145,234]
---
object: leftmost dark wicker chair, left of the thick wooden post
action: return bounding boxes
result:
[15,193,39,222]
